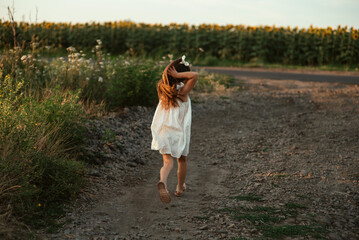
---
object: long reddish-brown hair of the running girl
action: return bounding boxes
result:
[157,58,191,109]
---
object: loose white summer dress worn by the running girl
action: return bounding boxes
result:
[151,83,192,158]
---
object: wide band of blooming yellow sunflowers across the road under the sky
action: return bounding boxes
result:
[0,21,359,66]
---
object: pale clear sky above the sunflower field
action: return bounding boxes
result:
[0,0,359,28]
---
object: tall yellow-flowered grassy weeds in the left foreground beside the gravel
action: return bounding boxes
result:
[0,72,85,239]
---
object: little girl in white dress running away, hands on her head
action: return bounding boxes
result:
[151,56,198,203]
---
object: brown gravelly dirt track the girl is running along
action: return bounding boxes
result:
[37,78,359,239]
